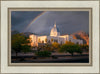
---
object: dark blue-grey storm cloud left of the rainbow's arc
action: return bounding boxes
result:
[11,11,42,32]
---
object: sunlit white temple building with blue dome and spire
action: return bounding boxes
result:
[29,23,83,46]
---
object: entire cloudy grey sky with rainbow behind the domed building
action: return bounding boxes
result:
[11,11,89,35]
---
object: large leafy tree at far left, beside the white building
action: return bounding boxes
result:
[11,33,30,56]
